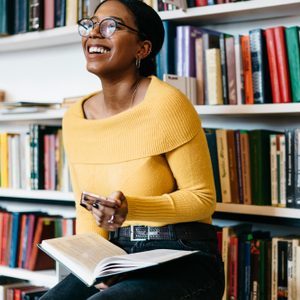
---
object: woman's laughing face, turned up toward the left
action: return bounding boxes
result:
[82,0,140,77]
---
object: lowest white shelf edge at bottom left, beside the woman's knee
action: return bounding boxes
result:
[0,266,58,287]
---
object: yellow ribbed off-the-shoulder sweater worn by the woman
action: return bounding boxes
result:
[63,76,216,236]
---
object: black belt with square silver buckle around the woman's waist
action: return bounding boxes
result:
[110,222,216,241]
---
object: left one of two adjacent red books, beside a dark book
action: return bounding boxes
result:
[265,28,281,103]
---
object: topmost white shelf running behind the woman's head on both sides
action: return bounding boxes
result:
[0,0,300,53]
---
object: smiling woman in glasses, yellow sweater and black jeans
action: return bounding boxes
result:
[42,0,224,300]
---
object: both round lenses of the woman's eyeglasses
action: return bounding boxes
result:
[78,19,117,38]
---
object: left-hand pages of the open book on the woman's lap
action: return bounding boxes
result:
[40,233,127,282]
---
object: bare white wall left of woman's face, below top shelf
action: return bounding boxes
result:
[0,42,101,101]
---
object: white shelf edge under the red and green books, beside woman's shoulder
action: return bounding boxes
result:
[196,103,300,116]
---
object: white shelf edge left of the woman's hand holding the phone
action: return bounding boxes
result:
[0,188,74,202]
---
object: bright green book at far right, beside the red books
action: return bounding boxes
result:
[285,26,300,102]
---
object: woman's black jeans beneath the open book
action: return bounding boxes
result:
[41,224,224,300]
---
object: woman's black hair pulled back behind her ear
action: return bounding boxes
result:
[95,0,165,77]
